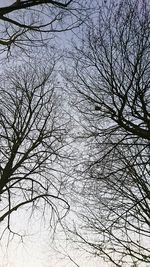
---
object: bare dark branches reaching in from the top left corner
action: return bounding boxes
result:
[0,0,84,55]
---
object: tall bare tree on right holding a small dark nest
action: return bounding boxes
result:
[66,0,150,267]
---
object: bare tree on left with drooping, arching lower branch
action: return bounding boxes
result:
[0,58,69,239]
